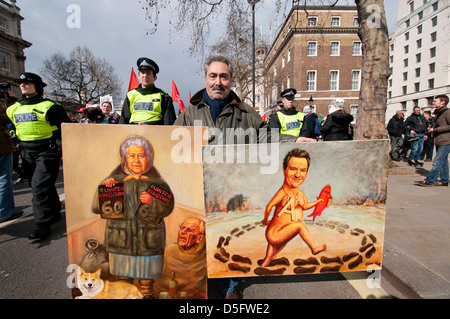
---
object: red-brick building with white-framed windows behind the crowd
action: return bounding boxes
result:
[264,6,362,119]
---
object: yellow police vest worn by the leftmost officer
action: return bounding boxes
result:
[6,101,58,142]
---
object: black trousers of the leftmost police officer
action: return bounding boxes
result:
[20,140,61,226]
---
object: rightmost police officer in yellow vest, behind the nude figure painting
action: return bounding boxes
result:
[269,88,307,142]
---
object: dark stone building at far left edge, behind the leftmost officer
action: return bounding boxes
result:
[0,0,31,97]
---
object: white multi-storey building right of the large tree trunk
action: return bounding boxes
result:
[386,0,450,121]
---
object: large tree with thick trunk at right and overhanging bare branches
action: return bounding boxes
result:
[140,0,390,139]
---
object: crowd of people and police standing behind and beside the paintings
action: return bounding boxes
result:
[0,55,450,298]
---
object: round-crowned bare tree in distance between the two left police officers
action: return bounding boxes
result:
[40,46,122,109]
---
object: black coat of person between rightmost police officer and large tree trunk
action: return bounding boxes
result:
[320,111,353,141]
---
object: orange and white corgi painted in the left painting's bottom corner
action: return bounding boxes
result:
[76,267,143,299]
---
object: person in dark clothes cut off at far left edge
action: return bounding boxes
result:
[0,106,23,223]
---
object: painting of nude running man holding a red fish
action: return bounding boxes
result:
[203,140,389,278]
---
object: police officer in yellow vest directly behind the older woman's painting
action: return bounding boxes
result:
[119,58,176,125]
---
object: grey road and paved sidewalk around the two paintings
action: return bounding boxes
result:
[0,162,450,299]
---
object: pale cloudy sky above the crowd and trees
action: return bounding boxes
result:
[17,0,397,108]
